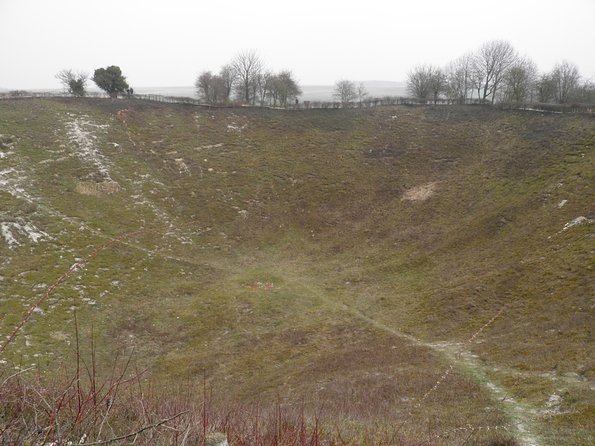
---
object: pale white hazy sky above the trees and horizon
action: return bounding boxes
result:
[0,0,595,89]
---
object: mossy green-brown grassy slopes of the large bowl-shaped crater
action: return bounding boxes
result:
[0,100,595,444]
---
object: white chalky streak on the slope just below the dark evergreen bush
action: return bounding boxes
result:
[65,113,113,181]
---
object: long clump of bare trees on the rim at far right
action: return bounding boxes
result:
[407,40,595,104]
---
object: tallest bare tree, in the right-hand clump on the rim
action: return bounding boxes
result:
[473,40,517,104]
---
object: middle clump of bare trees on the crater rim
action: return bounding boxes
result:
[195,51,302,107]
